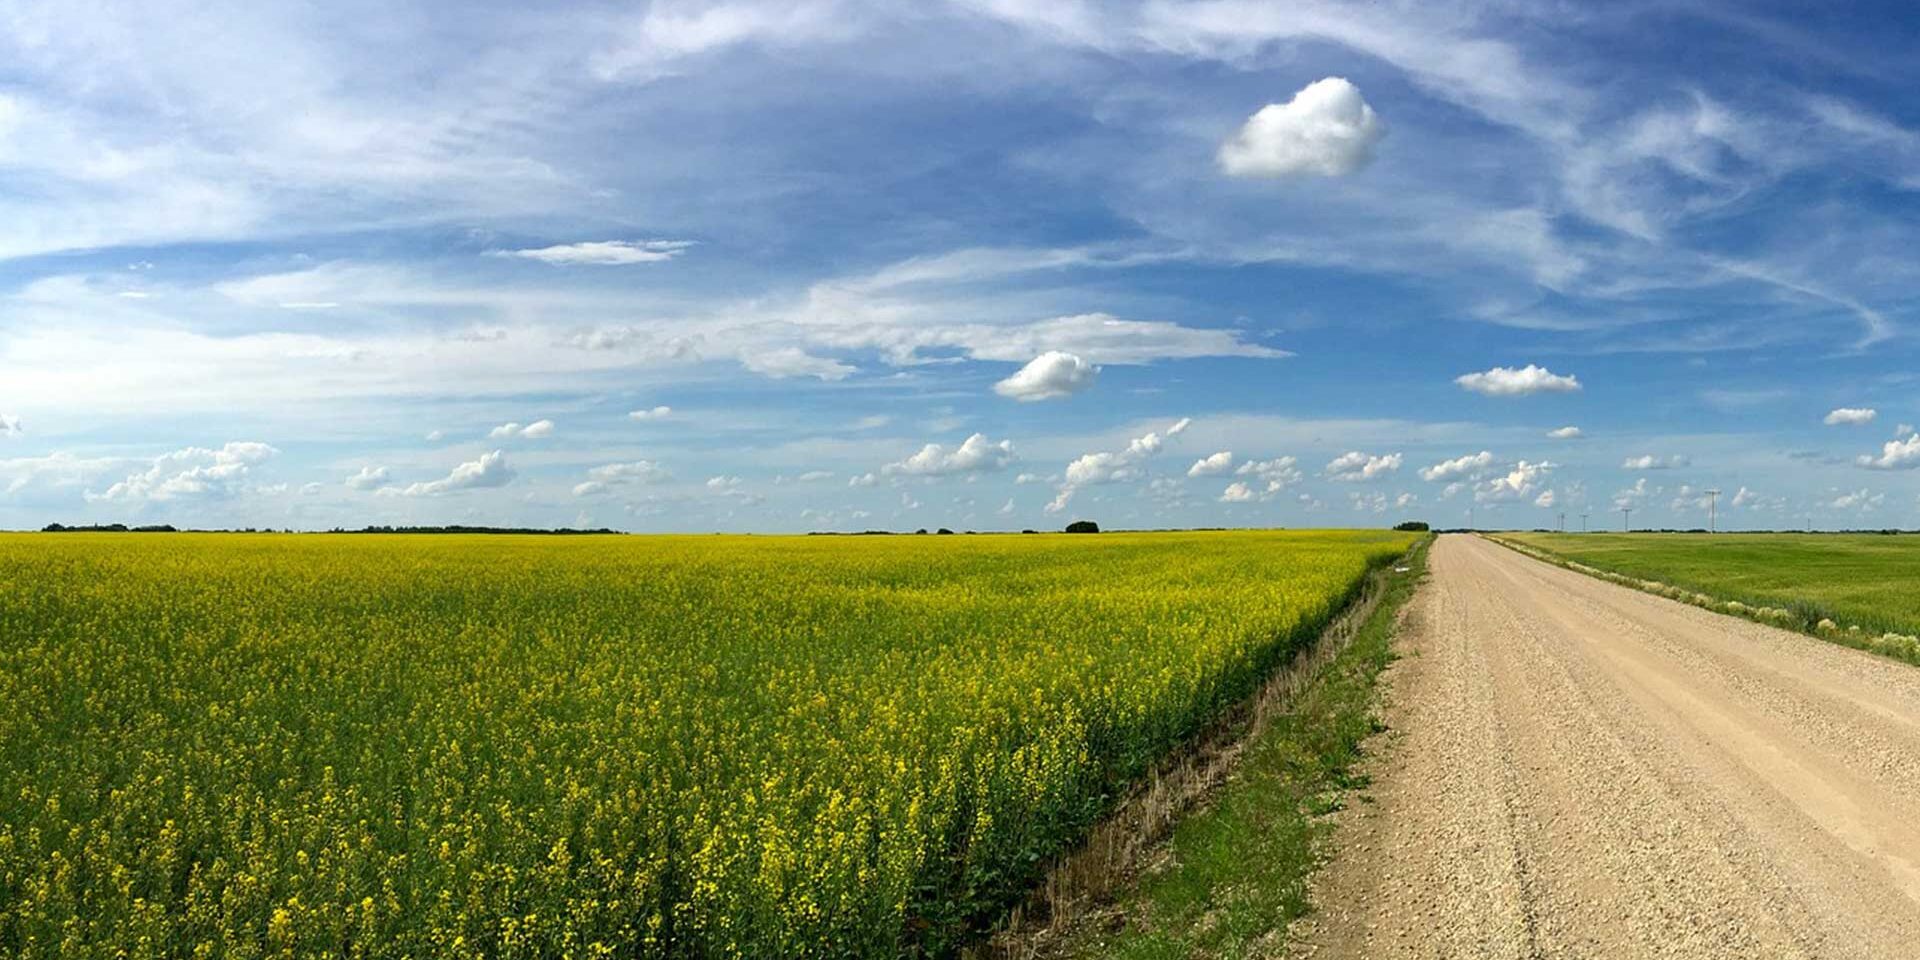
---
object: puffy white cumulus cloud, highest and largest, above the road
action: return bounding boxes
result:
[1219,77,1386,177]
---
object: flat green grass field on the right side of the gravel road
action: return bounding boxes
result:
[1501,534,1920,648]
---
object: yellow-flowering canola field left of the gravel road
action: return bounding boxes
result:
[0,532,1411,958]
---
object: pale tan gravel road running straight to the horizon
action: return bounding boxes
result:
[1296,536,1920,958]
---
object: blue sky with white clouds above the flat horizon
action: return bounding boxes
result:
[0,0,1920,532]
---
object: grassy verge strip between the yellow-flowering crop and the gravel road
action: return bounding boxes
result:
[998,540,1430,958]
